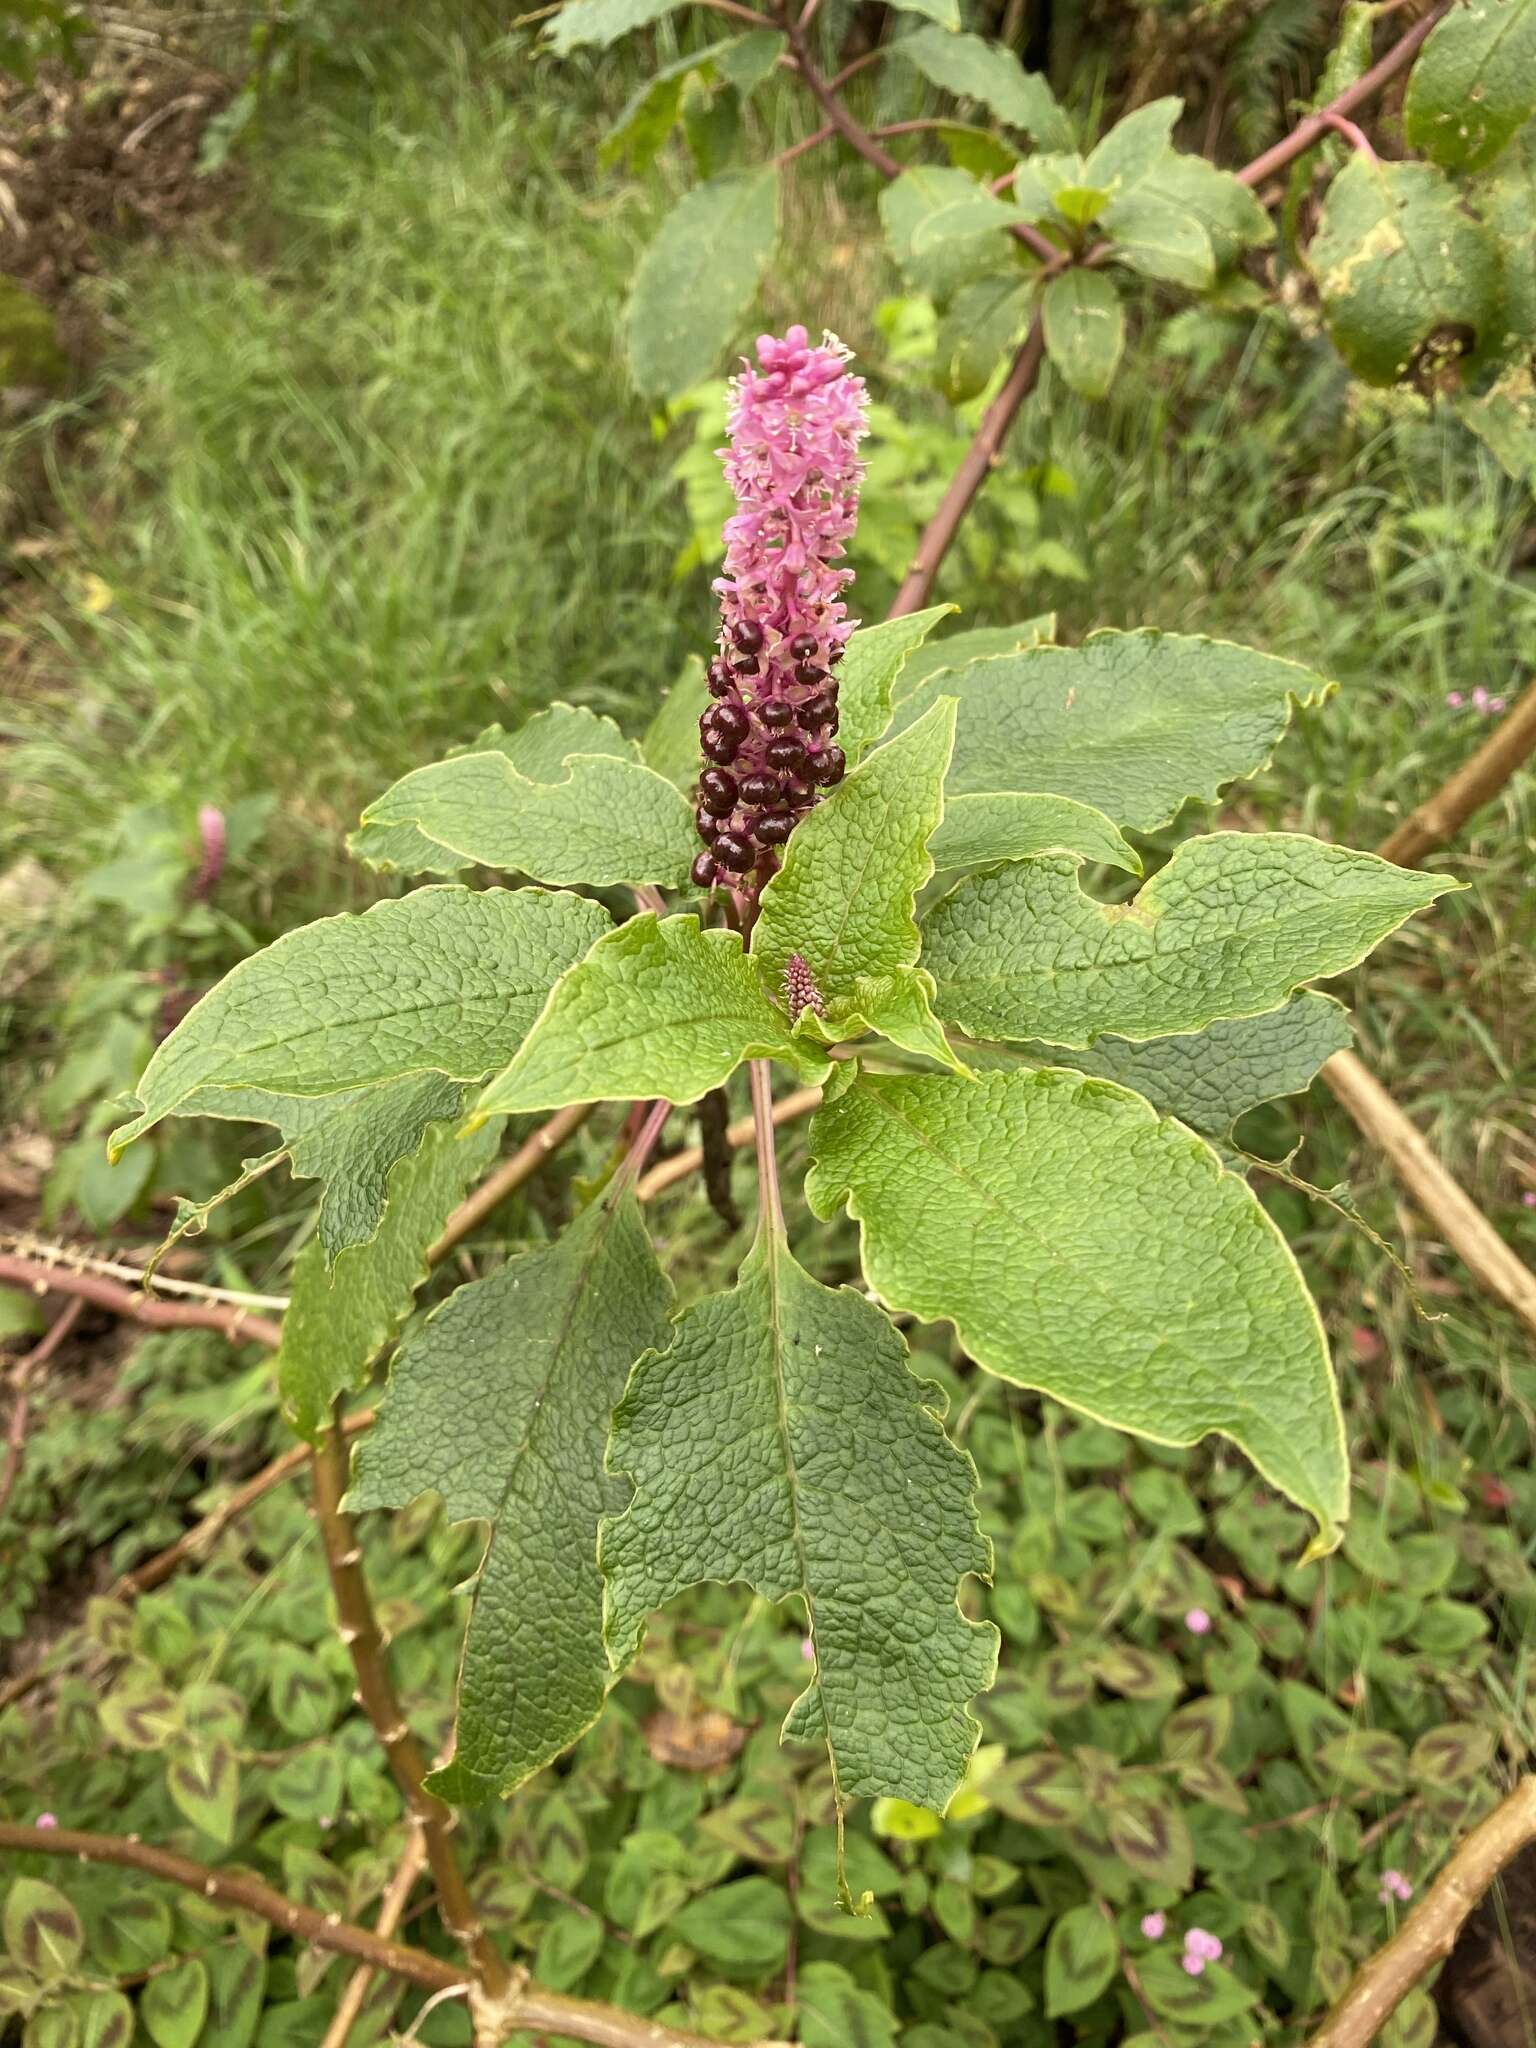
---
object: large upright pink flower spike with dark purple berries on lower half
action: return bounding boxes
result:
[694,328,868,891]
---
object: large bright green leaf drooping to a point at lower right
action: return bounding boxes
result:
[807,1069,1348,1536]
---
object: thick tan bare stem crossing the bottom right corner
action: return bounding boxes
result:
[1309,1778,1536,2048]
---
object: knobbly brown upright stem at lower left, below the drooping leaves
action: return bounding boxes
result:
[313,1430,512,1997]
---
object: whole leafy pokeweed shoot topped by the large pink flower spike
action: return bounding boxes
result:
[99,328,1454,1905]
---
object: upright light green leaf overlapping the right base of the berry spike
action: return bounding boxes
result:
[752,698,954,1051]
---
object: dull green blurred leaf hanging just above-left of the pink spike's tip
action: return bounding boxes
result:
[625,166,778,397]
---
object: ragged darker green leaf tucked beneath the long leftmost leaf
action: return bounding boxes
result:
[172,1073,465,1260]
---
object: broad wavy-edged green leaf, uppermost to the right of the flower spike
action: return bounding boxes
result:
[895,631,1333,831]
